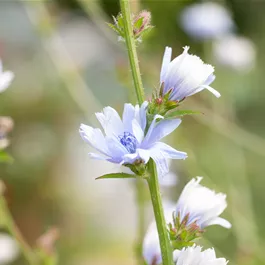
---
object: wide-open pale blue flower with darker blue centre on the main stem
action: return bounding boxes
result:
[79,102,187,177]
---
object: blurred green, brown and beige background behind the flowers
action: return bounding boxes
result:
[0,0,265,265]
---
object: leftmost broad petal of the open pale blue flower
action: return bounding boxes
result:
[79,124,109,156]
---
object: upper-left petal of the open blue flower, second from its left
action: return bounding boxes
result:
[96,107,124,136]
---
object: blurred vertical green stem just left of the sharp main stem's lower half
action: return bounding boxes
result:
[135,178,145,264]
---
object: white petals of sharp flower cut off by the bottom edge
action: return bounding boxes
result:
[174,245,228,265]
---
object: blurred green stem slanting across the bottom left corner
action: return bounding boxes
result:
[0,197,36,265]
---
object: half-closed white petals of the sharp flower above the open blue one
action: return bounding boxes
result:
[160,47,221,101]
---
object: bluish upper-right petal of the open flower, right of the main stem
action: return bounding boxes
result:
[143,119,181,147]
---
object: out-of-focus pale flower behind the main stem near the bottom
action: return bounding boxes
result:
[143,202,175,265]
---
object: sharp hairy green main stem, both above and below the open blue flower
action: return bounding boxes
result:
[120,0,173,265]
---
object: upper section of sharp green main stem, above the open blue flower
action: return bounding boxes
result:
[120,0,144,104]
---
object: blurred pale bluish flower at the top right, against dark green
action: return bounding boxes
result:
[181,2,235,40]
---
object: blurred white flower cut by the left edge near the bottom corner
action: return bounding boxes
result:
[0,234,19,265]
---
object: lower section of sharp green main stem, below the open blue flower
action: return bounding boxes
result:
[147,159,174,265]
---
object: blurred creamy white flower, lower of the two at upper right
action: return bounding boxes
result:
[213,35,256,71]
